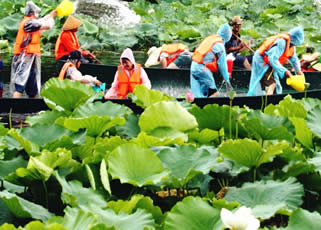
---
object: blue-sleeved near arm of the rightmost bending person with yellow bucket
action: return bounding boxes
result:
[265,38,291,78]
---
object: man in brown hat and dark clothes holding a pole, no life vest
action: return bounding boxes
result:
[225,16,253,70]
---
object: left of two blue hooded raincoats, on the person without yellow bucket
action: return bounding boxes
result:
[190,24,232,97]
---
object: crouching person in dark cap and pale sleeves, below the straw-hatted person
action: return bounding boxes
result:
[58,50,101,86]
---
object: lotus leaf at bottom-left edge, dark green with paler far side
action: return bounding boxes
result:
[0,191,53,221]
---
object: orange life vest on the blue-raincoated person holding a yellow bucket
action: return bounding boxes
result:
[258,33,294,65]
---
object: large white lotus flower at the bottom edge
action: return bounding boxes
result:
[221,206,260,230]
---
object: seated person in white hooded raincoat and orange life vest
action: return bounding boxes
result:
[104,48,151,99]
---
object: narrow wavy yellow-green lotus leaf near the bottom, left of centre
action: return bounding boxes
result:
[107,195,163,224]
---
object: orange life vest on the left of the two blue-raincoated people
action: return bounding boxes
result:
[192,34,223,73]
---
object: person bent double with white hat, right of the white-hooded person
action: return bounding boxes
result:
[145,43,193,69]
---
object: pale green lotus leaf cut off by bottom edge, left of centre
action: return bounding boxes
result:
[62,207,98,230]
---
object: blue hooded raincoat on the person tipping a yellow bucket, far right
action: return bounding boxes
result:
[247,27,304,96]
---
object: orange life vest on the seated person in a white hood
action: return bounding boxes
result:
[117,63,142,99]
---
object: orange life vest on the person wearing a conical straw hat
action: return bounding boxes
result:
[55,31,80,60]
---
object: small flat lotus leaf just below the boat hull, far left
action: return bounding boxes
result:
[26,110,65,126]
